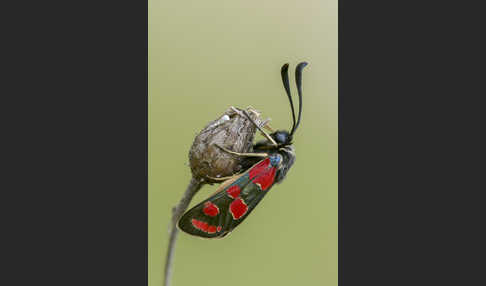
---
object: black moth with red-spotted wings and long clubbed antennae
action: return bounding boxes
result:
[178,62,307,238]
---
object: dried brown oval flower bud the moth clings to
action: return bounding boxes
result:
[189,107,265,184]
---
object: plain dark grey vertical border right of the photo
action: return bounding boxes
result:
[338,0,486,286]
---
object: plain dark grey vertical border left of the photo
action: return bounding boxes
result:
[0,0,148,285]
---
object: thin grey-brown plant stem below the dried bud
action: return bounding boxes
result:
[164,178,203,286]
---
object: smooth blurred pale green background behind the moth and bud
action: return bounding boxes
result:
[148,0,338,286]
